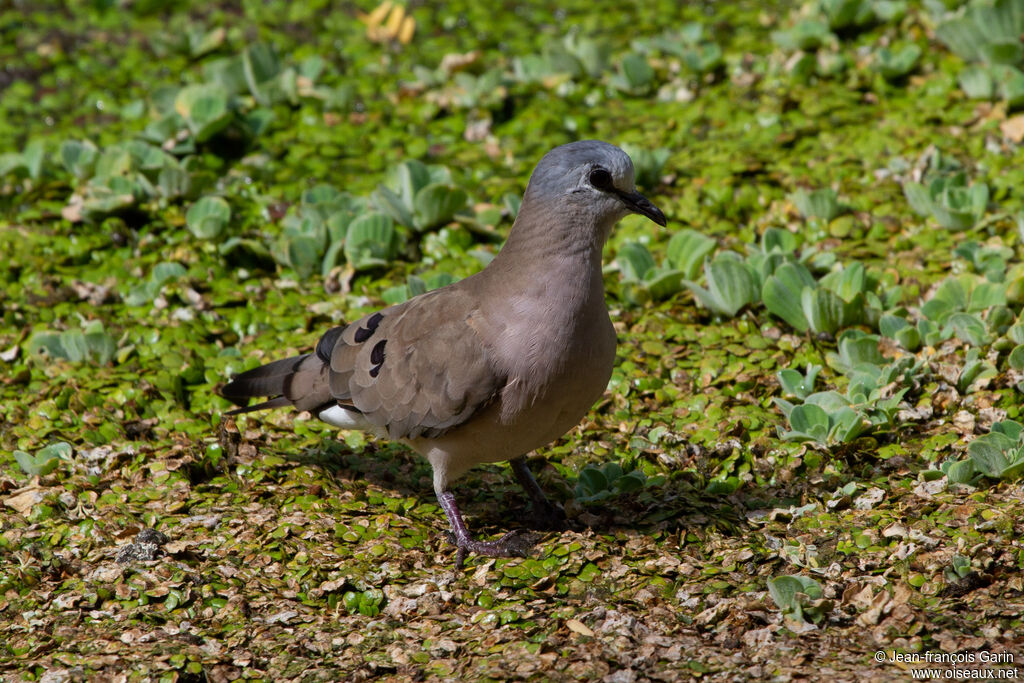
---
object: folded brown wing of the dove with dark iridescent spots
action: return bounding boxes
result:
[316,287,507,438]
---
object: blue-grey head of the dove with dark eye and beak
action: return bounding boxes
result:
[523,140,666,228]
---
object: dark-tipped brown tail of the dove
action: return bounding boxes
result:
[220,353,335,415]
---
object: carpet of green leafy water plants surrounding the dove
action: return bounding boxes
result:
[0,0,1024,680]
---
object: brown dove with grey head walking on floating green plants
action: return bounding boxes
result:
[220,140,667,567]
